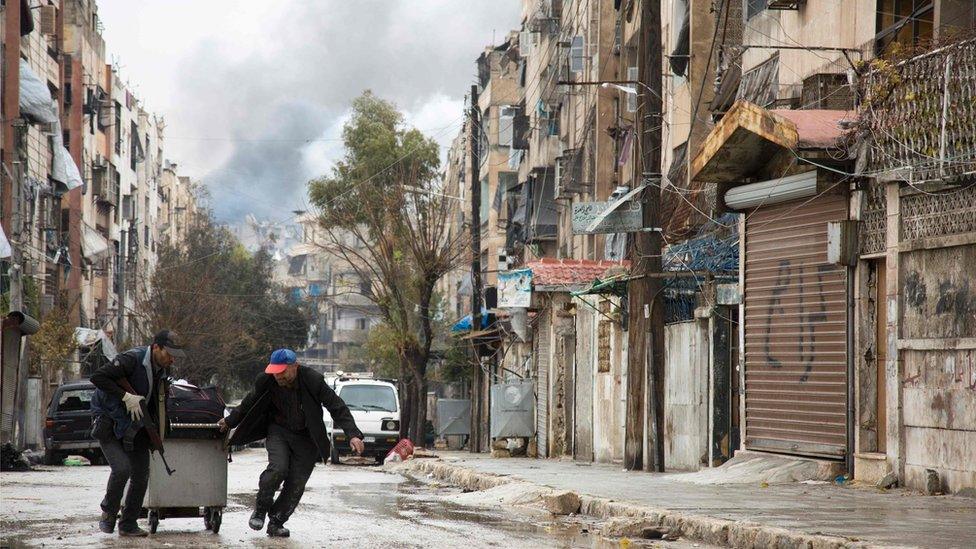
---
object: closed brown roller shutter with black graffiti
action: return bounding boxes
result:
[744,195,848,457]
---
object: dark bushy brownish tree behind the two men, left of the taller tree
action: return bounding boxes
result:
[139,212,309,396]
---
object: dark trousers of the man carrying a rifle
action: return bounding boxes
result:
[98,432,149,529]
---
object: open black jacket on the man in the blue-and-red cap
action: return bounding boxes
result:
[226,366,363,461]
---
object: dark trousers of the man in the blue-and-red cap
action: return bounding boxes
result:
[257,423,319,524]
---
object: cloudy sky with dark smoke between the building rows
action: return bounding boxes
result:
[98,0,521,222]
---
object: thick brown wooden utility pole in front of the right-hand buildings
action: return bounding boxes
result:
[624,0,664,471]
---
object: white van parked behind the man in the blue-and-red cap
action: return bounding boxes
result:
[324,374,400,464]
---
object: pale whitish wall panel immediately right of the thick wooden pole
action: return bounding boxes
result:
[664,321,709,471]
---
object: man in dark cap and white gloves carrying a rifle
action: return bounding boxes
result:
[91,330,186,537]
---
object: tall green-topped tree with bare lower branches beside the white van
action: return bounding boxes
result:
[309,91,464,441]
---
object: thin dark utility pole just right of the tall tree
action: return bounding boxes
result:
[468,84,482,453]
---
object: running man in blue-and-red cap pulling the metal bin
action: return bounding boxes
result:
[219,349,363,537]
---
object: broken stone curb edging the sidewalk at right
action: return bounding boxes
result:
[384,459,874,549]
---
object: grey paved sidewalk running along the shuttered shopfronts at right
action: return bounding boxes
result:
[390,452,976,548]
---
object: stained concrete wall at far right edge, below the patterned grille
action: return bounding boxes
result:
[899,244,976,492]
